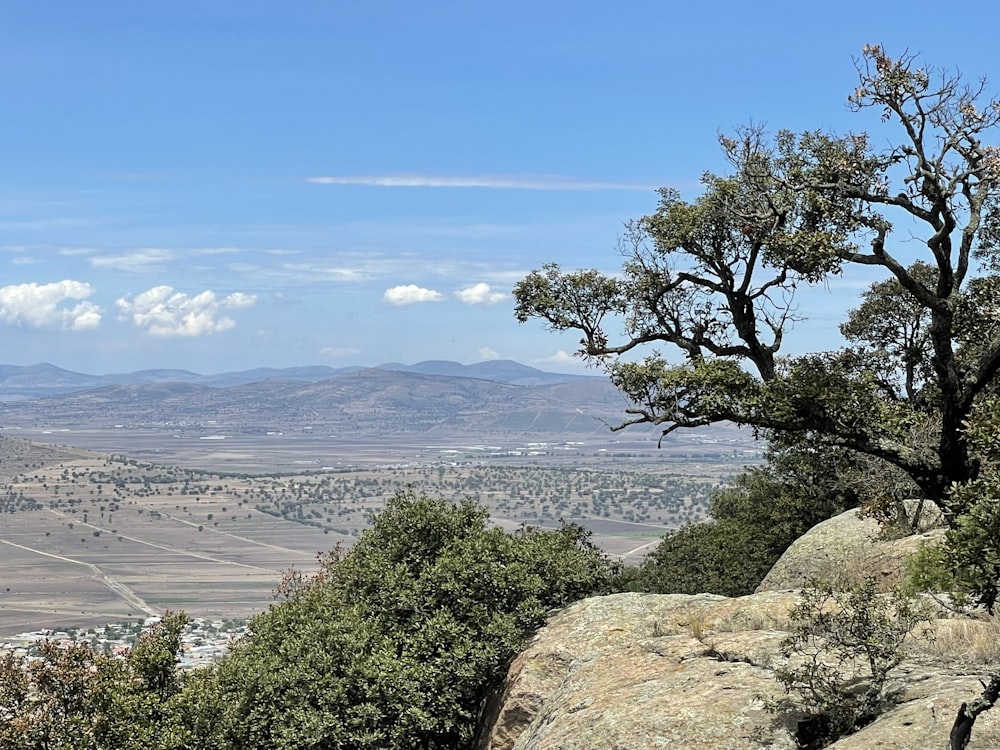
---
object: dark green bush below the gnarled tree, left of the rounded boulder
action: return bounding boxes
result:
[629,446,859,596]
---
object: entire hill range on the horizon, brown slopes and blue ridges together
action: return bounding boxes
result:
[0,360,640,439]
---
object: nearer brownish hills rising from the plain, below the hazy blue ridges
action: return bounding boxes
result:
[0,368,640,435]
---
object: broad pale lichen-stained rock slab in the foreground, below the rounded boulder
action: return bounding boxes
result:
[478,591,1000,750]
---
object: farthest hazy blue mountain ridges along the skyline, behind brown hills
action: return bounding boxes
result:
[0,359,593,401]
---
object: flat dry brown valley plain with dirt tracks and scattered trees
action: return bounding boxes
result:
[0,430,750,636]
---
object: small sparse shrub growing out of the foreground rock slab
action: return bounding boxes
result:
[771,578,927,747]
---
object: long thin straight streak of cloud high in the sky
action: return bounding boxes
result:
[306,174,654,190]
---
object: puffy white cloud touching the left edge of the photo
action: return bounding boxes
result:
[0,279,101,331]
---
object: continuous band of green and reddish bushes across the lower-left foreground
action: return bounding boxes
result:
[0,492,619,750]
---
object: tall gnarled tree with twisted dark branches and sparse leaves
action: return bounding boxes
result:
[515,45,1000,604]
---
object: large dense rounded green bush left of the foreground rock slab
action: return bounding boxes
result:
[177,492,617,750]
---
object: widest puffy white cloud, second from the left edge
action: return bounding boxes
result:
[115,286,257,337]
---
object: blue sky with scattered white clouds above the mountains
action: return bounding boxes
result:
[0,0,1000,373]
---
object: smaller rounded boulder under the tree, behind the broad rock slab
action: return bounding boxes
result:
[757,510,944,592]
